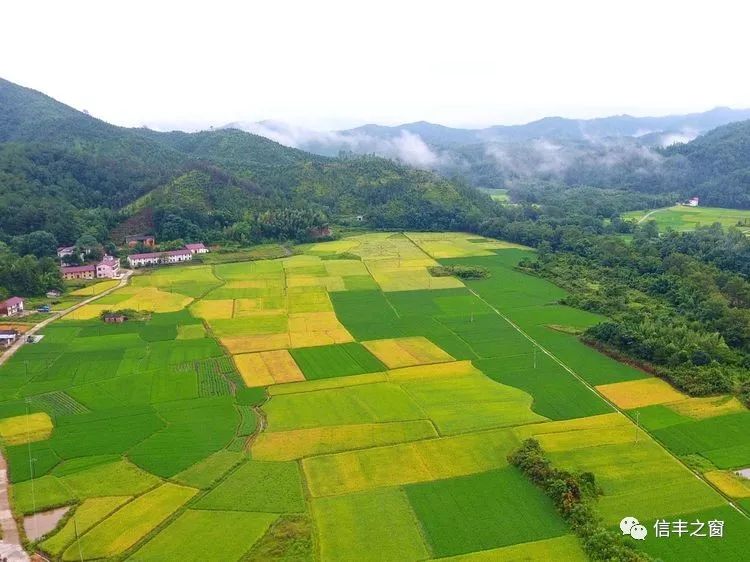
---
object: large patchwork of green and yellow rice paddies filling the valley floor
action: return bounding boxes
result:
[0,233,750,561]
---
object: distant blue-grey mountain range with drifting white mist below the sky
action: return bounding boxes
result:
[227,107,750,196]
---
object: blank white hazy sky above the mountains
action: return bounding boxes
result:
[0,0,750,129]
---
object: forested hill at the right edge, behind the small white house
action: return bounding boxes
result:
[665,121,750,209]
